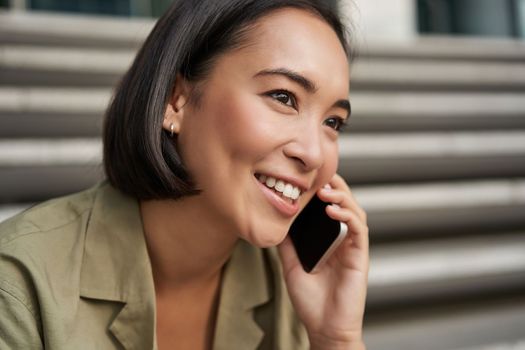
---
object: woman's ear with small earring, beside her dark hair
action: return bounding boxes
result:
[162,74,190,134]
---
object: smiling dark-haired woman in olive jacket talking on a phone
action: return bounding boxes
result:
[0,0,368,349]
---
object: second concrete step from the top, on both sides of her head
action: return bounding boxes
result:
[4,45,525,91]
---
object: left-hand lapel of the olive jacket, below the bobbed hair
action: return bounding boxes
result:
[80,184,156,349]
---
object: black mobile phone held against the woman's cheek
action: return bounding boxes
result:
[288,196,348,273]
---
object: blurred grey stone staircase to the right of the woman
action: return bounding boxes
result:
[350,38,525,350]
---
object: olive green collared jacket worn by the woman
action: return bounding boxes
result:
[0,183,308,350]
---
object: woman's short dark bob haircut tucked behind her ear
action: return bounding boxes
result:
[103,0,350,200]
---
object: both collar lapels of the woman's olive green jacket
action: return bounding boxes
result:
[80,183,272,350]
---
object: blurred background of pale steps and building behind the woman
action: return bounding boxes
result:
[0,0,525,350]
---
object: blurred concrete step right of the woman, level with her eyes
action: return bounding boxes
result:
[348,91,525,133]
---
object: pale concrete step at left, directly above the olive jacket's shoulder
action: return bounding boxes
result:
[0,139,103,203]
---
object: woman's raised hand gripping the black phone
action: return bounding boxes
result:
[279,175,369,349]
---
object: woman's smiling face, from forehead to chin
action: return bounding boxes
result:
[174,9,349,247]
